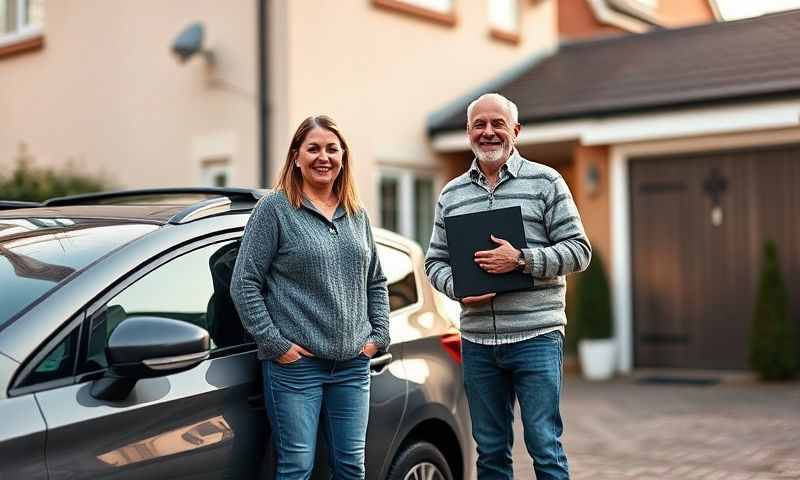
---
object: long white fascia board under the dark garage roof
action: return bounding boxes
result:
[432,99,800,152]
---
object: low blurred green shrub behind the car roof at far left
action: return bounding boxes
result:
[0,159,108,202]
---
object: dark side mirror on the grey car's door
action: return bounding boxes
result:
[92,317,210,401]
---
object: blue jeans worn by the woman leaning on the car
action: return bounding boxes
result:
[261,354,369,480]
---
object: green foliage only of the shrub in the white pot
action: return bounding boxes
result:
[572,252,614,340]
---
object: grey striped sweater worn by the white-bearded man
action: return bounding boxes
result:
[425,150,592,339]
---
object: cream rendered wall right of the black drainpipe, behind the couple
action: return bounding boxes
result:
[272,0,557,218]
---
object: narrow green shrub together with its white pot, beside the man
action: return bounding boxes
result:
[573,252,616,380]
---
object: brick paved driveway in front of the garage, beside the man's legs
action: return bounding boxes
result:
[506,377,800,480]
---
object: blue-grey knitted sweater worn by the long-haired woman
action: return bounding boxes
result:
[231,192,389,360]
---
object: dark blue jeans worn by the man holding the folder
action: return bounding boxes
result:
[461,332,569,480]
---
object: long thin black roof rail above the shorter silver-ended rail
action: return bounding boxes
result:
[41,187,267,207]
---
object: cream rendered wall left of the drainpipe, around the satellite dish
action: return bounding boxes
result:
[0,0,258,187]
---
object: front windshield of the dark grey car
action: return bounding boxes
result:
[0,218,158,328]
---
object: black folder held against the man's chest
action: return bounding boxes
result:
[444,206,533,298]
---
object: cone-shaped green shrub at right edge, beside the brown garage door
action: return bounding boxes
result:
[750,241,797,380]
